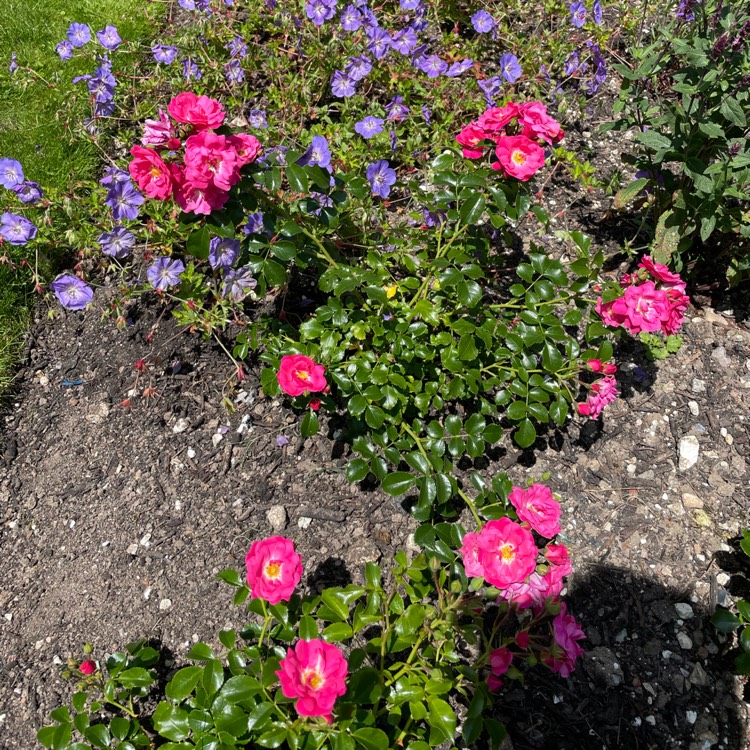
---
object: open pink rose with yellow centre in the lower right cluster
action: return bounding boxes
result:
[477,518,537,589]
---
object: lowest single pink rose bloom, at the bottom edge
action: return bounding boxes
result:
[276,638,347,724]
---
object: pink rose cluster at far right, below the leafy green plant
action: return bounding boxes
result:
[596,255,690,335]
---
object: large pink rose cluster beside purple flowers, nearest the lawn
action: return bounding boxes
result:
[129,91,261,215]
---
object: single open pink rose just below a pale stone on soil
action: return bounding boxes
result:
[245,536,302,604]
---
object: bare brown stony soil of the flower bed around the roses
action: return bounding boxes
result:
[0,67,750,750]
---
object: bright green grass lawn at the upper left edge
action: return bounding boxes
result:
[0,0,159,391]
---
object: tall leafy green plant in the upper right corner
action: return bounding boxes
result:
[605,0,750,282]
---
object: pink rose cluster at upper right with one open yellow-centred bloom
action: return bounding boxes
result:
[456,102,565,182]
